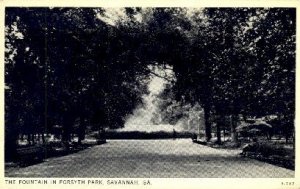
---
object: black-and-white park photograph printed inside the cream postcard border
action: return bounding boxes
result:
[3,6,296,180]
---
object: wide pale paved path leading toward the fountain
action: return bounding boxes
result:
[5,139,294,178]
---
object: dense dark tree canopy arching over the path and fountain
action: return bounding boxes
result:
[5,8,296,160]
